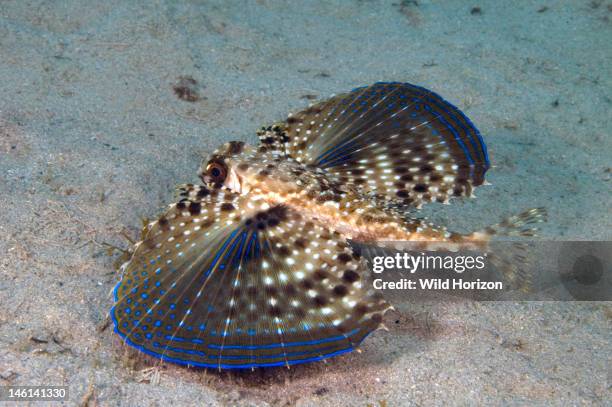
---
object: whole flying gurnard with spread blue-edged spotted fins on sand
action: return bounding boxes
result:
[110,82,545,370]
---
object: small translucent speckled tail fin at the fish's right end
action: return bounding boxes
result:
[471,208,547,292]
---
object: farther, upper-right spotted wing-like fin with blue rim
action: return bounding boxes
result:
[259,83,489,207]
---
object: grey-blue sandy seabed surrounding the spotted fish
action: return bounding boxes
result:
[0,0,612,406]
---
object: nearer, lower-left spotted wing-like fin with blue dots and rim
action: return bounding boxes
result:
[111,185,388,369]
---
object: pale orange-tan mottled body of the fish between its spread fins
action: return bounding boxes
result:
[200,141,450,243]
